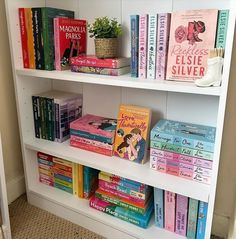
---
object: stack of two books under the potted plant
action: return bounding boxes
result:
[70,55,130,76]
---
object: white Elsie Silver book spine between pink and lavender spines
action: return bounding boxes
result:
[147,14,157,79]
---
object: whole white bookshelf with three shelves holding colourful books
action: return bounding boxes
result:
[5,0,236,239]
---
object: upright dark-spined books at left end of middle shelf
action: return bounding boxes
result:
[32,90,83,142]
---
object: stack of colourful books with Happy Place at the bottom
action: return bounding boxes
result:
[90,172,153,228]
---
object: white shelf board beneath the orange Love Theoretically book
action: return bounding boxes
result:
[24,138,210,202]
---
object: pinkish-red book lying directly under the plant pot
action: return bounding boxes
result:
[70,55,130,69]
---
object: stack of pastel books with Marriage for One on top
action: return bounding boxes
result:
[150,120,216,184]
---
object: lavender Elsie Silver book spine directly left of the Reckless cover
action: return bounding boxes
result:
[156,13,171,80]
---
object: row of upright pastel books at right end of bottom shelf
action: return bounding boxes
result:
[154,188,208,239]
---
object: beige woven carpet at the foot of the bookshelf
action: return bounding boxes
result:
[9,195,104,239]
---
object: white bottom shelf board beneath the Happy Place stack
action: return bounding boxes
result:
[29,182,186,239]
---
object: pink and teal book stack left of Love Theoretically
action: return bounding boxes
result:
[70,114,117,156]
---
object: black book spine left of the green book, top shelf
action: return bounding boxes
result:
[32,8,44,70]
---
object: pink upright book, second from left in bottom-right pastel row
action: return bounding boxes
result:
[165,191,175,232]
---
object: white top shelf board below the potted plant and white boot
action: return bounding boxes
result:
[16,69,221,96]
